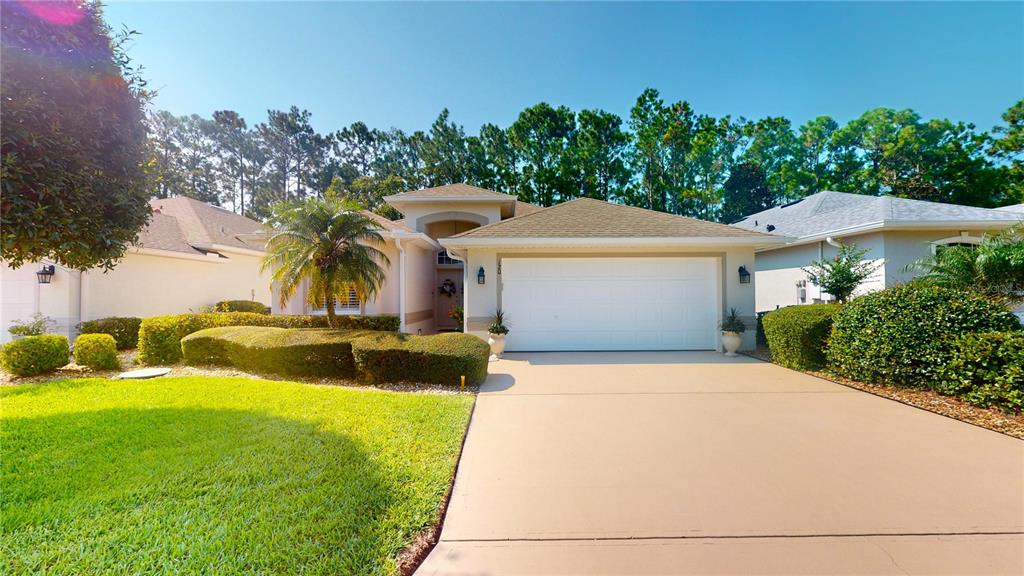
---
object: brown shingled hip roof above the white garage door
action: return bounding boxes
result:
[453,198,769,239]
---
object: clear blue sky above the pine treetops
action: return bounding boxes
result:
[105,2,1024,133]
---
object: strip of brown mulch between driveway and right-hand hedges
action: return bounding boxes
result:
[749,346,1024,440]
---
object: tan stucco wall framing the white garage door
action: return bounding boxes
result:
[464,246,756,349]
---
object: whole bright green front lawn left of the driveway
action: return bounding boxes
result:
[0,377,473,574]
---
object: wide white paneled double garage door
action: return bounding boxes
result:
[501,257,721,352]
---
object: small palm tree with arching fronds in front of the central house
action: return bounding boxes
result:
[261,196,390,326]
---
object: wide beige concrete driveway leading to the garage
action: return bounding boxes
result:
[418,353,1024,575]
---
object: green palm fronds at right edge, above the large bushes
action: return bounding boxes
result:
[906,224,1024,307]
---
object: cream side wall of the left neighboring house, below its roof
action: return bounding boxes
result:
[82,252,270,320]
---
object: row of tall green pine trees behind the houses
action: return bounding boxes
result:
[147,89,1024,222]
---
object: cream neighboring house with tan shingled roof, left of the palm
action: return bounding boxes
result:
[0,197,270,341]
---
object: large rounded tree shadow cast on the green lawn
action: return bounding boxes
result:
[0,408,395,574]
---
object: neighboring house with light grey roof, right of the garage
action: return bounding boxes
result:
[734,192,1024,312]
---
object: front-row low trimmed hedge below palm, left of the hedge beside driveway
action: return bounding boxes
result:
[181,326,381,378]
